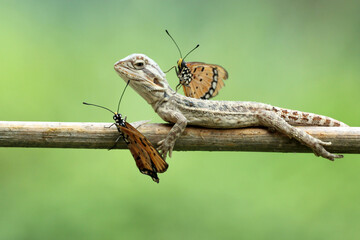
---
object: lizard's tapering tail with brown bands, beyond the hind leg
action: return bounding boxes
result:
[272,107,348,127]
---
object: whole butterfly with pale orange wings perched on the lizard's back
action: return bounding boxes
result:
[165,30,229,99]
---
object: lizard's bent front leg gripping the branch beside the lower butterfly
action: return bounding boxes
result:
[158,112,187,160]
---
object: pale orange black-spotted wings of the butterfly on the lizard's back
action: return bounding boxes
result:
[183,62,229,99]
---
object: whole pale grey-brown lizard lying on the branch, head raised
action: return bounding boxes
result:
[114,54,348,161]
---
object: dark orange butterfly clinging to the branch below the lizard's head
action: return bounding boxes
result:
[83,81,168,183]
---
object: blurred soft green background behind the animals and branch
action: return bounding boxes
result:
[0,0,360,240]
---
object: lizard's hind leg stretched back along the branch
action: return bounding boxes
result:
[257,111,343,161]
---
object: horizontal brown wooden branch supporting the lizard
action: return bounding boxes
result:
[0,121,360,153]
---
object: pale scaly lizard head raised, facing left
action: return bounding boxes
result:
[114,54,169,92]
